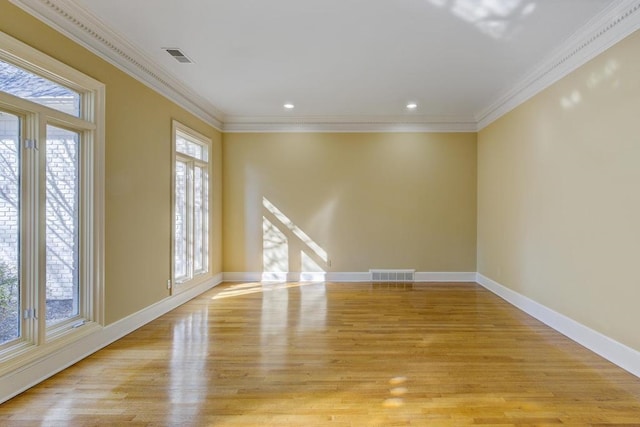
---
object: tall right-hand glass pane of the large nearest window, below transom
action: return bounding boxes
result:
[45,126,80,325]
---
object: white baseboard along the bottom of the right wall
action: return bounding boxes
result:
[476,273,640,378]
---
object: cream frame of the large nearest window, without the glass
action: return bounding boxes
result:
[0,32,105,375]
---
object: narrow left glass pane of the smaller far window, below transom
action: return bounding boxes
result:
[174,160,188,282]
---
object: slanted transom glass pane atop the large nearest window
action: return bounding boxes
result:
[0,61,80,117]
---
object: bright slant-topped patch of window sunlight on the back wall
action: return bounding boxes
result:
[262,197,329,281]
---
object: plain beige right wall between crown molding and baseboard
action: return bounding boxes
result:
[478,29,640,350]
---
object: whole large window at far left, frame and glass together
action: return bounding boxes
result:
[0,33,104,372]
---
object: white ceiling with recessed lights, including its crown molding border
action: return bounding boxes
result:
[14,0,640,131]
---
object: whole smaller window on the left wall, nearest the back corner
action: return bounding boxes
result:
[173,121,211,291]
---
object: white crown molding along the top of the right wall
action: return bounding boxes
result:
[476,0,640,130]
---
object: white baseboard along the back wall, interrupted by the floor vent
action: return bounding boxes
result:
[224,271,476,282]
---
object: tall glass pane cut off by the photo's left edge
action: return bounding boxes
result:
[0,111,20,344]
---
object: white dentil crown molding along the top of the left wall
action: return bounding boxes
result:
[9,0,224,130]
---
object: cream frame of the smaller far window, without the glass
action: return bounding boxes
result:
[171,120,213,295]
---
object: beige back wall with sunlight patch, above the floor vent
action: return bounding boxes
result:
[223,133,476,272]
